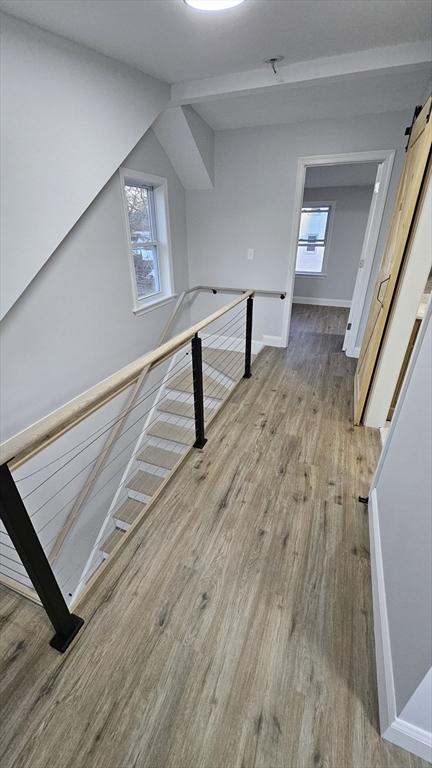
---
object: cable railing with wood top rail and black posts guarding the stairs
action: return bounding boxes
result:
[0,286,285,651]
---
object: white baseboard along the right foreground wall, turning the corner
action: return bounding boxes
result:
[369,488,432,761]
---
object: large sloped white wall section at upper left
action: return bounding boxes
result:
[1,14,169,316]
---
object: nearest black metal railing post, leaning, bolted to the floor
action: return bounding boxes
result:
[0,464,84,653]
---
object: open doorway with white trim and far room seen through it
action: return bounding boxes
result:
[284,150,395,357]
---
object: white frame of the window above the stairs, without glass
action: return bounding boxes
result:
[119,168,175,315]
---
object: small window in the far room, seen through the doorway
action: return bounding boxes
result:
[296,205,332,275]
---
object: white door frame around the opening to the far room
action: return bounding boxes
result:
[282,149,396,357]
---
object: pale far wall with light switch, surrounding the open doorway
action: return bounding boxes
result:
[186,112,411,338]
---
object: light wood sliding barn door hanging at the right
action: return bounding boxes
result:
[354,98,432,424]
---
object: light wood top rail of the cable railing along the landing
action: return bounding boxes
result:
[0,289,255,470]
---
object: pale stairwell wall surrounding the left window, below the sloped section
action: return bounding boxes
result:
[0,131,189,440]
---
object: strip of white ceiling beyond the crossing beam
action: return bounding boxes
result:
[193,67,430,130]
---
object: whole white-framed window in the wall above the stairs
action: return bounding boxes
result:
[120,169,172,312]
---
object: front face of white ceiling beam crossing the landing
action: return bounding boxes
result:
[170,41,431,106]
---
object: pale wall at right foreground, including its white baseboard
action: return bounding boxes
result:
[370,306,432,759]
